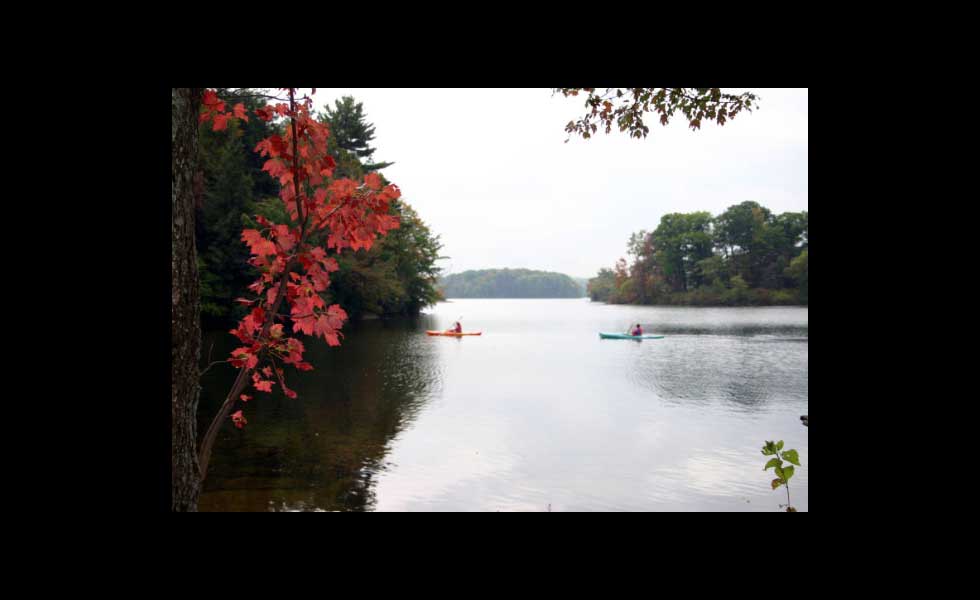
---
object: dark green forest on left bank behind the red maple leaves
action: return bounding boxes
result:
[195,88,441,329]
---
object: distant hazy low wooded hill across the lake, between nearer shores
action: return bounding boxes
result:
[439,269,585,298]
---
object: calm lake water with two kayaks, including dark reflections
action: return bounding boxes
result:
[199,299,810,512]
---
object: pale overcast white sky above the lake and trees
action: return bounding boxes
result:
[302,88,809,278]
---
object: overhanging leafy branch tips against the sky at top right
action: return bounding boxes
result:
[555,88,759,142]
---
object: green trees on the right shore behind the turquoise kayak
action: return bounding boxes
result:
[588,201,809,306]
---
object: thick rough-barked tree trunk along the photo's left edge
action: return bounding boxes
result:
[170,88,203,512]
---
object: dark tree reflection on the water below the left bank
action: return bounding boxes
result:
[199,317,441,511]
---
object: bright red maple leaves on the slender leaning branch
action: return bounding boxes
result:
[200,88,401,428]
